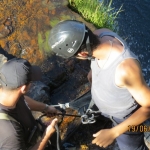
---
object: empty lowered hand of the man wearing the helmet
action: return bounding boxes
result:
[92,128,117,148]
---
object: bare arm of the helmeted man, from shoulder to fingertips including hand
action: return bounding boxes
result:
[92,59,150,147]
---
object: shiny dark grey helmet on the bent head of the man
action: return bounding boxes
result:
[48,20,90,58]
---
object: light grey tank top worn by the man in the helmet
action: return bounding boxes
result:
[91,32,139,119]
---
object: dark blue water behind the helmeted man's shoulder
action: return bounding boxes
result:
[112,0,150,86]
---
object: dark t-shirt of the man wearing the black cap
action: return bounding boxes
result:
[0,96,36,150]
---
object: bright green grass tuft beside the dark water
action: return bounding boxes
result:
[69,0,122,31]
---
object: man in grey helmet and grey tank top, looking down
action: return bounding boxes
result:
[49,20,150,150]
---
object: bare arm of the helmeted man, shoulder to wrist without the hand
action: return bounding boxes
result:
[111,59,150,135]
